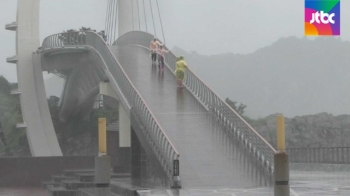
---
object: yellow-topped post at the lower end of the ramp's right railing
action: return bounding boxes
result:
[274,115,289,196]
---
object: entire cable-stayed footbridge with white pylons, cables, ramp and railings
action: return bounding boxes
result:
[7,0,286,193]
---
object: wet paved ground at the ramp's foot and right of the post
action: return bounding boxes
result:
[163,171,350,196]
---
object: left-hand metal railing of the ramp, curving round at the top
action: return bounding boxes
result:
[42,32,180,182]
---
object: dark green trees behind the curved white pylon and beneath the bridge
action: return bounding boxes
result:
[0,72,119,156]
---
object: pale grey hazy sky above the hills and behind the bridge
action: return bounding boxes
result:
[0,0,350,81]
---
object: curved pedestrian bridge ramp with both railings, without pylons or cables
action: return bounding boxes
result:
[39,31,276,188]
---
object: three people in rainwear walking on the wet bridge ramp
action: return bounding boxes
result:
[149,38,188,88]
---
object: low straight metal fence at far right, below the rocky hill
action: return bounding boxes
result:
[286,147,350,164]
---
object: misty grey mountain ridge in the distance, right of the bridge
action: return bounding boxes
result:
[173,37,350,118]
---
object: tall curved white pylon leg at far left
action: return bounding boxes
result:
[16,0,62,157]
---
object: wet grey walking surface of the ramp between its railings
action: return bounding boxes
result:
[111,46,267,188]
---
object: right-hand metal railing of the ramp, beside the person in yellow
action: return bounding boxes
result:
[113,31,276,173]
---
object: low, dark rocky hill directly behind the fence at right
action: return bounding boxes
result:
[251,113,350,148]
